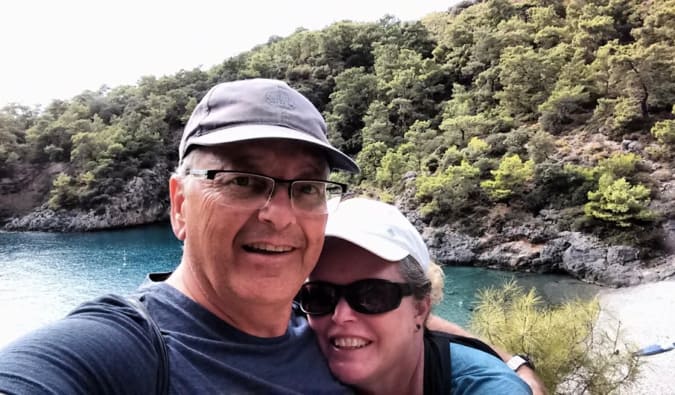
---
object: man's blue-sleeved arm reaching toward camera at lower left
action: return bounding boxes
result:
[0,301,159,394]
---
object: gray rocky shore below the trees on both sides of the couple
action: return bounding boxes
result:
[0,166,675,287]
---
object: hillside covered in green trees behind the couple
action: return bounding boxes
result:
[0,0,675,280]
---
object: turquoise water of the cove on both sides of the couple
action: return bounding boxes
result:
[0,225,595,344]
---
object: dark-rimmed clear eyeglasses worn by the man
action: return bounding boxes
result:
[188,170,347,215]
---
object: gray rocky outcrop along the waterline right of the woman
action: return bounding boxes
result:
[423,225,675,287]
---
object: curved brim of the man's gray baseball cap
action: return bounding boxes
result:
[185,124,359,173]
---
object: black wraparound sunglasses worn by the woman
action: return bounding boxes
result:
[298,278,413,315]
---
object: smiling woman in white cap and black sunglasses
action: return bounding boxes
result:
[299,198,530,394]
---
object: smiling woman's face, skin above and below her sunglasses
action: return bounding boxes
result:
[309,238,429,389]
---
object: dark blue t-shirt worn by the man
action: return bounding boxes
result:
[0,283,351,394]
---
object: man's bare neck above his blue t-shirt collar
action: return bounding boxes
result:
[166,263,292,337]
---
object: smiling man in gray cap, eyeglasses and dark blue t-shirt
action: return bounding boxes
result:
[0,79,540,394]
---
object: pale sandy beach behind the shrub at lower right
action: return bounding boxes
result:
[599,279,675,395]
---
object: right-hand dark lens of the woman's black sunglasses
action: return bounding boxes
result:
[345,279,402,314]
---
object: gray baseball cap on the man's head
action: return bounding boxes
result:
[178,78,359,173]
